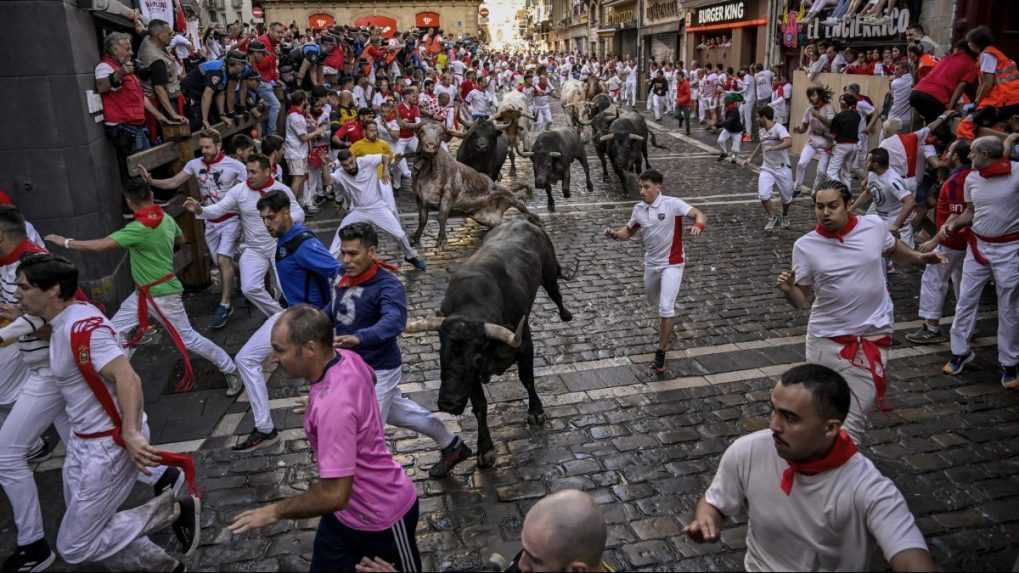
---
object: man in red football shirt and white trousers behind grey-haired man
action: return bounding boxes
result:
[906,140,972,345]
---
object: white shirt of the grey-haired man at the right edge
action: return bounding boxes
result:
[963,161,1019,237]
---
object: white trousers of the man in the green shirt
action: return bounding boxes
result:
[110,291,237,374]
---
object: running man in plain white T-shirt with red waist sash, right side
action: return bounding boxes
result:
[777,180,945,442]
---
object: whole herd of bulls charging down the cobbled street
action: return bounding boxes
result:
[393,81,648,468]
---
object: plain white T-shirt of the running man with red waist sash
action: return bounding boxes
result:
[793,215,896,338]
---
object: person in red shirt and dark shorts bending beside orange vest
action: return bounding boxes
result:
[909,42,979,123]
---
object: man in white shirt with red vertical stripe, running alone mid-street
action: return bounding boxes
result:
[605,169,707,374]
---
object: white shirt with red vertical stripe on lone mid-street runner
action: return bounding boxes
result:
[627,194,692,268]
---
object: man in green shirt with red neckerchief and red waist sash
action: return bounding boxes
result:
[46,177,242,390]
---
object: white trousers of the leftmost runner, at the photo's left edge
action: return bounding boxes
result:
[0,367,68,545]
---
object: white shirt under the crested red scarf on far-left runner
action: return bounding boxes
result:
[50,304,124,433]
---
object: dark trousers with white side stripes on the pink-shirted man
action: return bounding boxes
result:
[311,500,421,572]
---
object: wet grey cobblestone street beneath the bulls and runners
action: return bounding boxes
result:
[0,104,1019,571]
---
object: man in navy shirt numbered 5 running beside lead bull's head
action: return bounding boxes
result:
[328,222,471,478]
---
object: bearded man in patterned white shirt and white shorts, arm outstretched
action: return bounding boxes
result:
[139,129,245,330]
